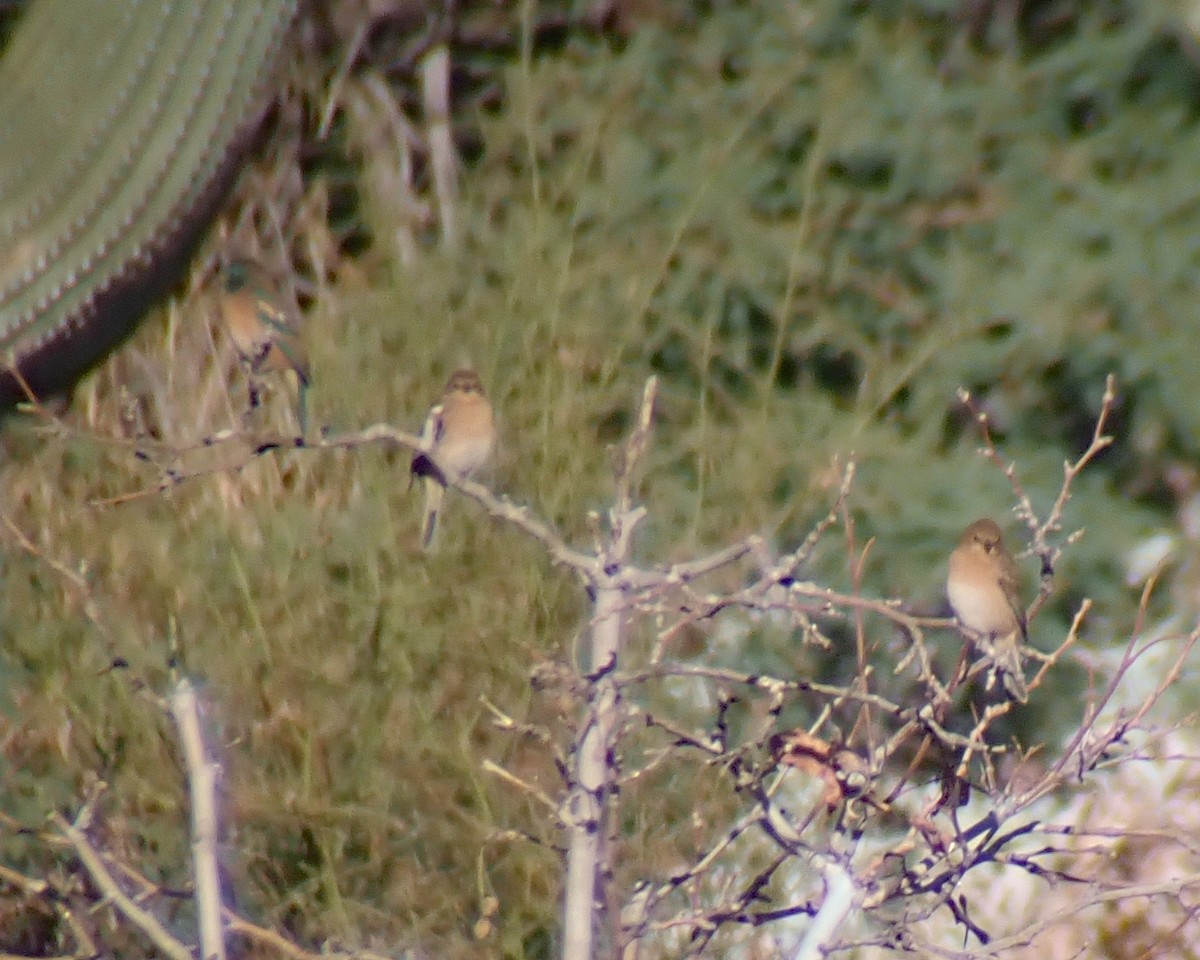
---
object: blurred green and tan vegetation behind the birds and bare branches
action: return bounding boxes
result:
[0,0,1200,958]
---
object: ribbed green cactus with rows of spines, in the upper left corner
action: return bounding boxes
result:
[0,0,298,408]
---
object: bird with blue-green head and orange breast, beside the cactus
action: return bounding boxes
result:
[221,260,310,436]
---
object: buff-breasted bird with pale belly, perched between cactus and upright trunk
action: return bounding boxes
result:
[409,370,496,550]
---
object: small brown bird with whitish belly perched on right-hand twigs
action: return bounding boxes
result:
[946,520,1028,703]
